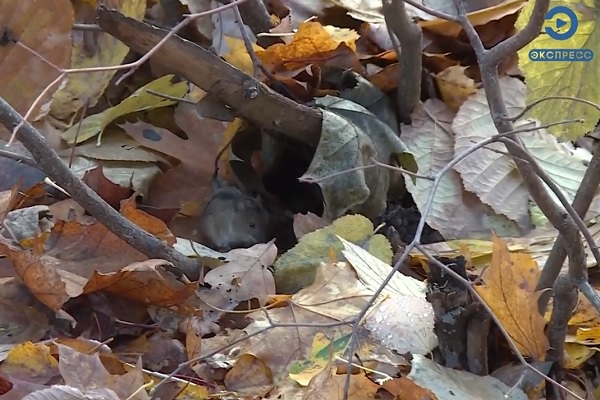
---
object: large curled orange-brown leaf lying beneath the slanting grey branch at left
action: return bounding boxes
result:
[0,200,195,311]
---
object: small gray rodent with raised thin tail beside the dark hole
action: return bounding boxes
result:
[197,139,273,252]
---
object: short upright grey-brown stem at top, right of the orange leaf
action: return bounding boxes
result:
[383,0,423,124]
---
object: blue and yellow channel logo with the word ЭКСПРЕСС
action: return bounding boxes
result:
[529,6,594,62]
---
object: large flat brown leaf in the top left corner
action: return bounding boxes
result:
[0,0,73,123]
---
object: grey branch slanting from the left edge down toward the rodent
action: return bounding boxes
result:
[0,97,200,280]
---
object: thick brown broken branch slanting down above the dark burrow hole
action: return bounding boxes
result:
[98,6,321,146]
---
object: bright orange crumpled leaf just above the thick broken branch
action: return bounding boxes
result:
[257,22,356,70]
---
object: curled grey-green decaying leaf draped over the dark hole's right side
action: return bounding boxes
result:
[302,96,408,219]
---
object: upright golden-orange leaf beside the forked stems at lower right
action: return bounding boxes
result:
[475,235,549,360]
